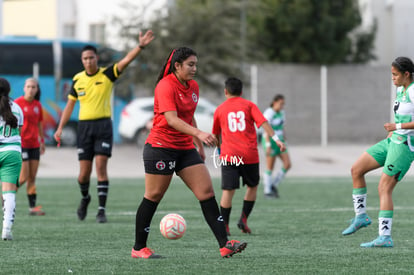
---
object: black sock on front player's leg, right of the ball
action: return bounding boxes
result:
[200,197,228,248]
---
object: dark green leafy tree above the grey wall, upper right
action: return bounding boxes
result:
[256,0,376,64]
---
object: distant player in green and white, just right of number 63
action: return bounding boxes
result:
[262,95,291,198]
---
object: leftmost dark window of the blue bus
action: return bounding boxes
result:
[0,43,53,75]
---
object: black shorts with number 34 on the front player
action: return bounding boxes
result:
[143,143,204,175]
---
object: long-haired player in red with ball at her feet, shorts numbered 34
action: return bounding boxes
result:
[131,47,247,259]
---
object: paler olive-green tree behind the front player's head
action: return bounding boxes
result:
[114,0,256,94]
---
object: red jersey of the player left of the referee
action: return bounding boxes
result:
[14,96,43,149]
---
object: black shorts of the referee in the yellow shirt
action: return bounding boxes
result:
[78,118,113,160]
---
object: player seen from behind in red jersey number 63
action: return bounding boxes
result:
[213,77,285,235]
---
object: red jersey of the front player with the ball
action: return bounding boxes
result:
[145,73,199,150]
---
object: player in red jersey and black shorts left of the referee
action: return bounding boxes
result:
[14,78,45,216]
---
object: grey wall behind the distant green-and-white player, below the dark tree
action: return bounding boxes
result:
[252,64,393,144]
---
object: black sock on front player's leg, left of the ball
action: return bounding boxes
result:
[134,198,158,250]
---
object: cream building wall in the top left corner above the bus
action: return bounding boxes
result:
[3,0,58,38]
